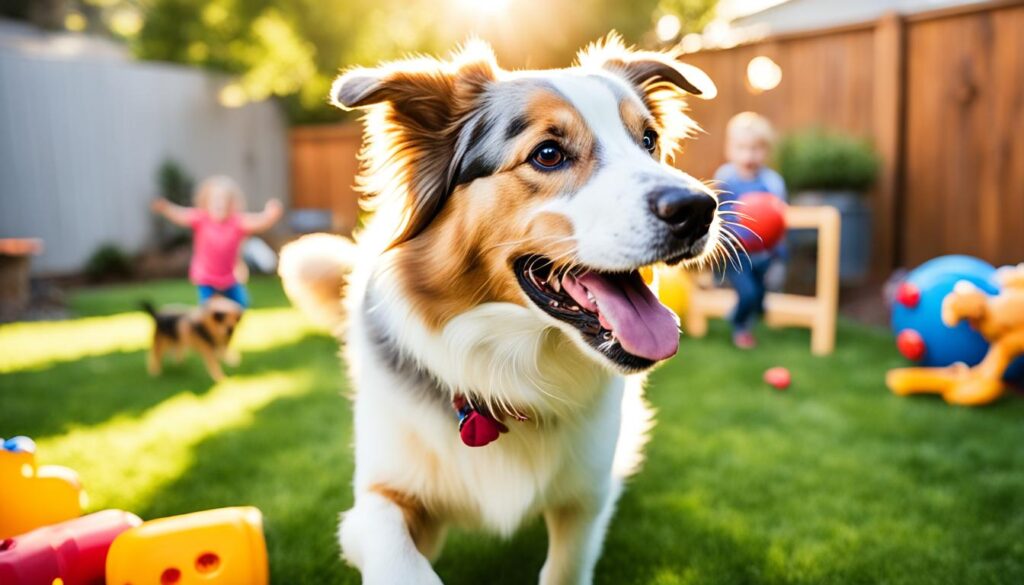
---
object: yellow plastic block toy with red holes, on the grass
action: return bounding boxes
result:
[106,507,268,585]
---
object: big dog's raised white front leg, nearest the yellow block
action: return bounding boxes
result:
[338,491,441,585]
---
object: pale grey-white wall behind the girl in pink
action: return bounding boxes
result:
[0,24,288,274]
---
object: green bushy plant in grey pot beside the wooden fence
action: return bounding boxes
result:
[776,129,880,282]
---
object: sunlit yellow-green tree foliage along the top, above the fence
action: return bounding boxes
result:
[11,0,716,123]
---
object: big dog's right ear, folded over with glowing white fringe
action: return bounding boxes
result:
[579,33,718,99]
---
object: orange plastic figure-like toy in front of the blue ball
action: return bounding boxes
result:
[886,264,1024,406]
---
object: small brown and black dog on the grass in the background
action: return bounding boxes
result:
[142,296,245,382]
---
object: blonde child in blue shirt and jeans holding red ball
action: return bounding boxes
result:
[715,112,786,349]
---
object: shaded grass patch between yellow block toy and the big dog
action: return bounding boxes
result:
[134,366,358,583]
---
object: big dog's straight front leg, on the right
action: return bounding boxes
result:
[541,489,617,585]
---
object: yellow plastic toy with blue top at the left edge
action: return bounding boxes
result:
[0,436,85,540]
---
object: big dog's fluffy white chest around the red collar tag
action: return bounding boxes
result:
[347,278,625,534]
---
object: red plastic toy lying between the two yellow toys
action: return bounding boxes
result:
[0,510,142,585]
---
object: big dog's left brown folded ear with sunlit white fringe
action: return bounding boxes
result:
[331,41,498,247]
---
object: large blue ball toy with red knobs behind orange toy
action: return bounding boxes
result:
[891,255,1024,383]
